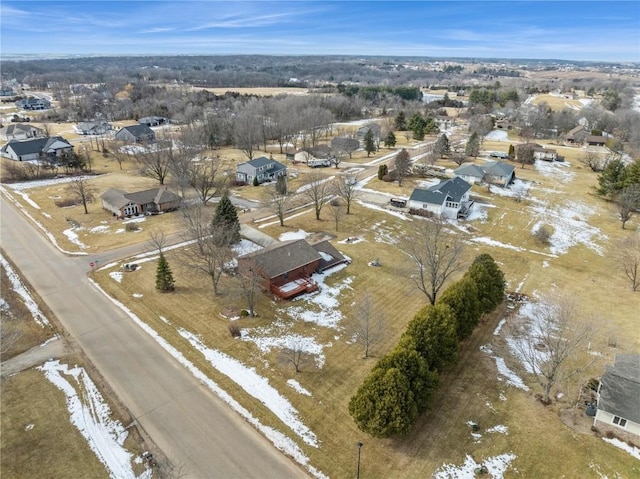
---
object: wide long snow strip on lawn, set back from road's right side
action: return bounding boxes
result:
[178,328,318,447]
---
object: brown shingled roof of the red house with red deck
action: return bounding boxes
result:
[238,239,322,278]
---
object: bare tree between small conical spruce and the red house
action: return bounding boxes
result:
[180,205,233,295]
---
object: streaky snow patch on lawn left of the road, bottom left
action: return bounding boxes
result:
[37,360,152,479]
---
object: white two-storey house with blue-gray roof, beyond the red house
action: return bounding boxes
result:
[409,177,473,219]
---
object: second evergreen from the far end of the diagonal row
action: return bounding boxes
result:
[438,275,482,340]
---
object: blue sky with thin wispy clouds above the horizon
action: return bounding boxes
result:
[0,0,640,62]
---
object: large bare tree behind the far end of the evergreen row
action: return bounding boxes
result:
[402,218,463,304]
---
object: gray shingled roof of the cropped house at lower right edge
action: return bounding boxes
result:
[598,354,640,424]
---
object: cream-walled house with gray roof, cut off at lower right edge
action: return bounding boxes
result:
[594,354,640,438]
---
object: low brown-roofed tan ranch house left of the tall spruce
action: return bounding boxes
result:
[100,186,182,218]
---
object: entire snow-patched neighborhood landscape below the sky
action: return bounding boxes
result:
[0,3,640,479]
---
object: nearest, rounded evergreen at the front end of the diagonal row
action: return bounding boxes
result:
[349,368,418,437]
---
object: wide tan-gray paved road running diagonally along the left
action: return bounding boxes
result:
[0,196,306,479]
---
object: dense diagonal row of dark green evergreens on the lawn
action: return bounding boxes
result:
[349,254,504,437]
